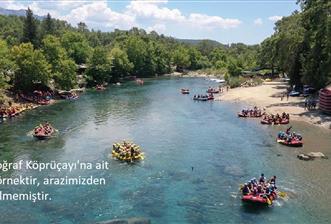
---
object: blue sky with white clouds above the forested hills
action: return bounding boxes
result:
[0,0,300,44]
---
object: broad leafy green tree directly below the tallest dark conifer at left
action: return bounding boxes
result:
[11,43,51,91]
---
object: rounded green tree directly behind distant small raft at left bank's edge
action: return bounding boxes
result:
[86,47,112,85]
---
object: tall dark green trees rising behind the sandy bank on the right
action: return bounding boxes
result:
[258,0,331,89]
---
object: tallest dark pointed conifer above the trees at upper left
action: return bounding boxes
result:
[22,8,38,46]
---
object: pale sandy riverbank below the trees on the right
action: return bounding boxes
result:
[218,82,331,130]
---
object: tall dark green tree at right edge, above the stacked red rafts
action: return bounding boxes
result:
[299,0,331,88]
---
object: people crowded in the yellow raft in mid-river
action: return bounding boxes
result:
[112,141,144,162]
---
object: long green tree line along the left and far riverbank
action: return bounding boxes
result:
[0,9,258,91]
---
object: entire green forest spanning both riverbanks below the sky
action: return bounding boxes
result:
[0,0,331,97]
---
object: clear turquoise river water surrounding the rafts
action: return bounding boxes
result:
[0,78,331,224]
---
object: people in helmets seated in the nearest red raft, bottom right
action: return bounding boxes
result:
[242,173,277,197]
